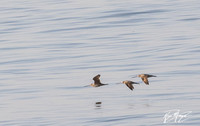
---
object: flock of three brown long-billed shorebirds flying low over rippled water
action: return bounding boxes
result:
[90,74,156,90]
